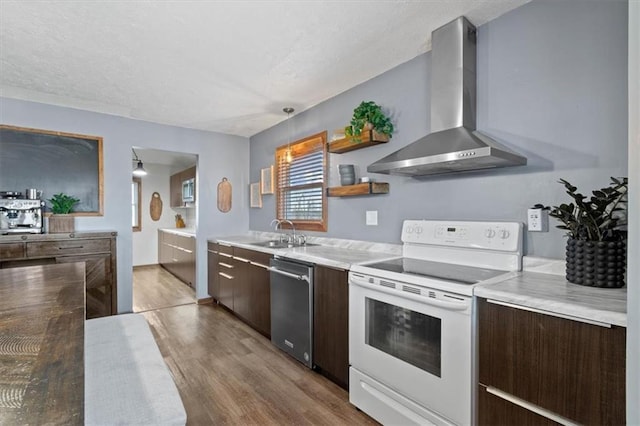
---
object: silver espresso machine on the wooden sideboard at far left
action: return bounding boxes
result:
[0,191,44,234]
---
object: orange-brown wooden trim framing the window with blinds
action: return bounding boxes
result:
[275,130,329,232]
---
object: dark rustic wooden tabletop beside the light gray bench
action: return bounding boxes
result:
[0,263,85,425]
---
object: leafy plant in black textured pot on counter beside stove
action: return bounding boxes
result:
[535,177,628,288]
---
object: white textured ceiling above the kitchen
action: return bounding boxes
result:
[0,0,529,136]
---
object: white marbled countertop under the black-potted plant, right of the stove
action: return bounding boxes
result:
[474,256,627,327]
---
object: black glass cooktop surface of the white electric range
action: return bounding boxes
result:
[362,257,507,285]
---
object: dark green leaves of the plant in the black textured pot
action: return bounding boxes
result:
[534,177,628,241]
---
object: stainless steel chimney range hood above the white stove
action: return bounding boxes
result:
[367,16,527,176]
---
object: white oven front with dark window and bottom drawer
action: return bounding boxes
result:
[349,274,472,424]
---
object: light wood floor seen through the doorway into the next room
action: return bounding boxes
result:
[133,265,195,312]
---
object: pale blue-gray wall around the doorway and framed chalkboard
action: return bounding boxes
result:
[0,98,249,312]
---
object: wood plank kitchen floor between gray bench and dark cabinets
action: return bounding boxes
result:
[143,304,377,425]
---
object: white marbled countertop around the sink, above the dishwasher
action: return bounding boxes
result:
[210,233,400,270]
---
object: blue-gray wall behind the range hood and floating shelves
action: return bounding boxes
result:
[250,0,627,258]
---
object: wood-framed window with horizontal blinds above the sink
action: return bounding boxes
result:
[276,131,327,231]
